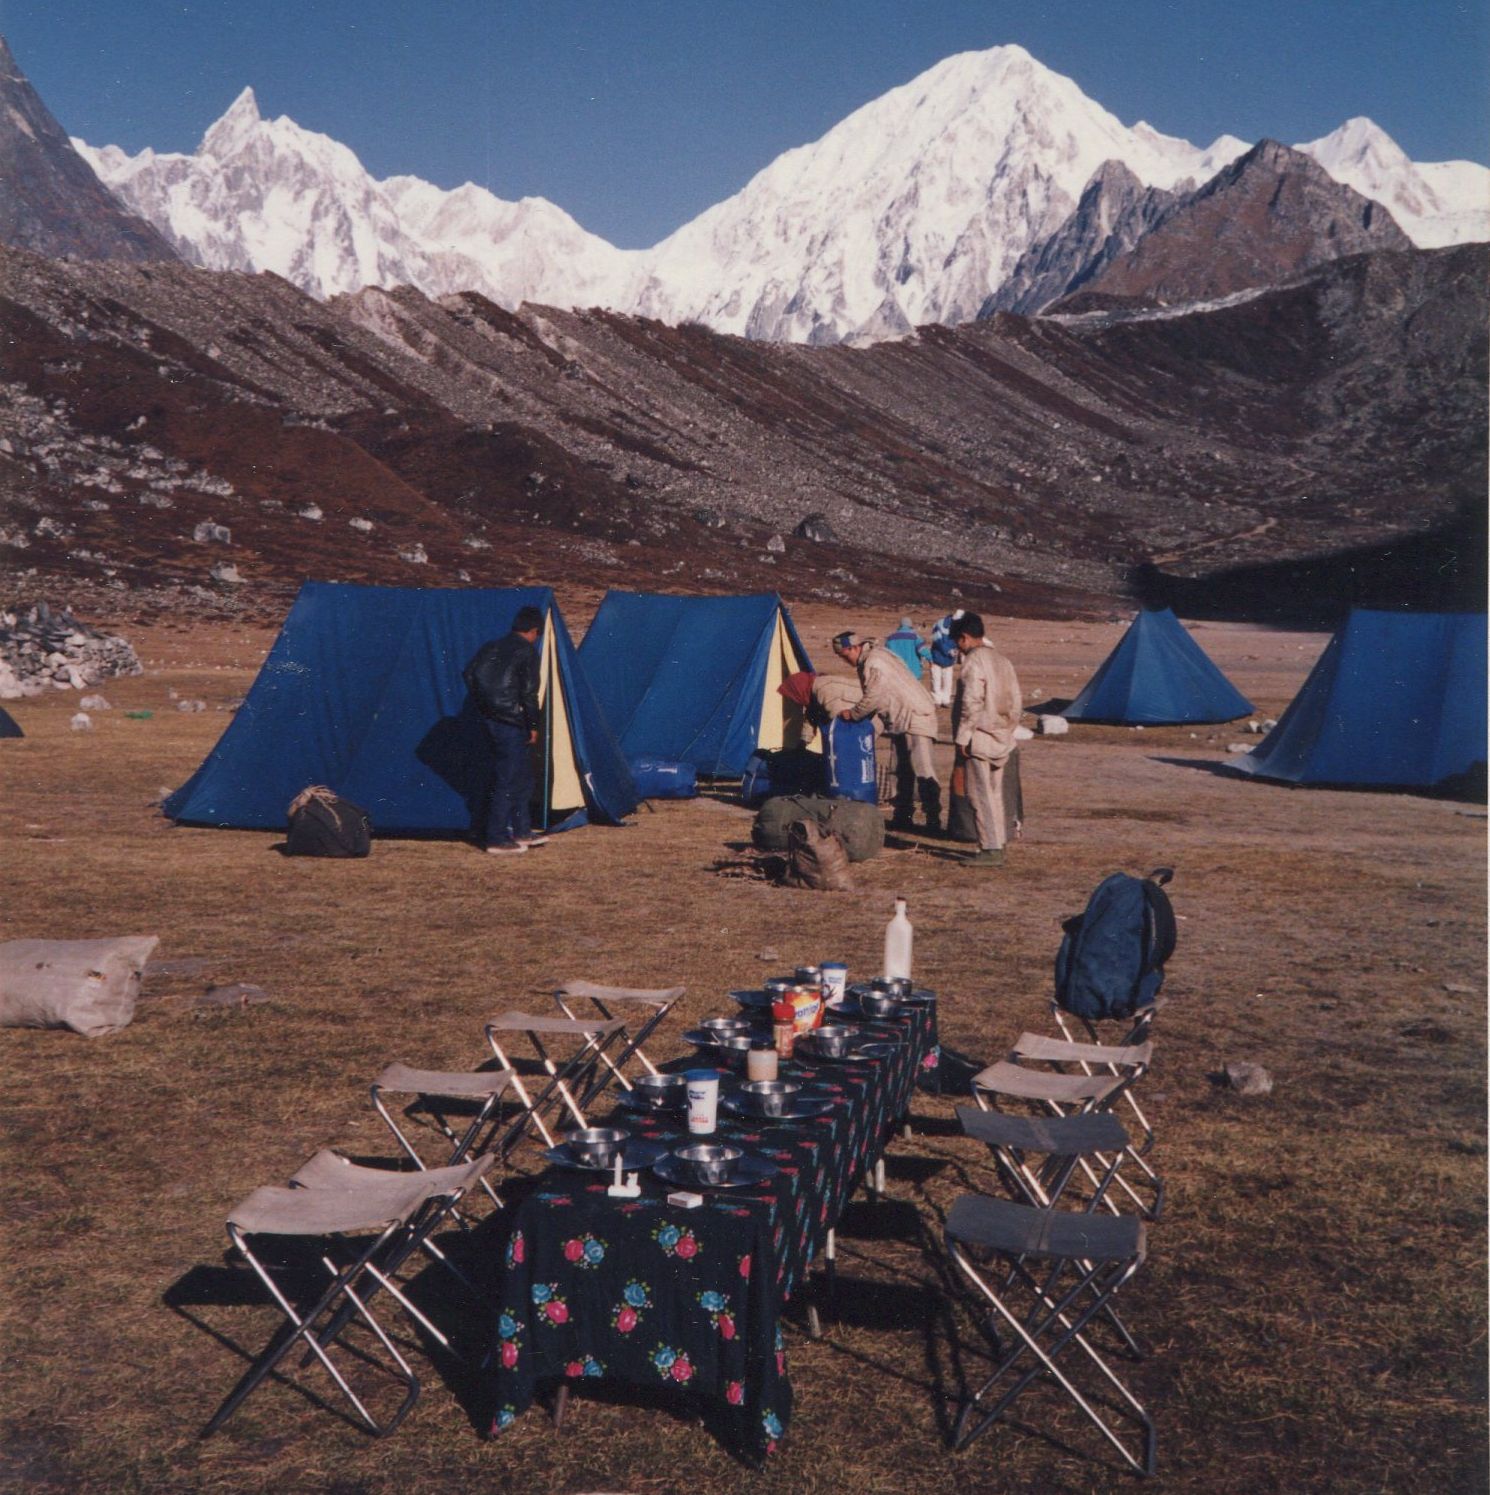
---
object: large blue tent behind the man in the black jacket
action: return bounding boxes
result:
[164,582,637,834]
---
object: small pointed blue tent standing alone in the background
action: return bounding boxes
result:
[1061,607,1252,727]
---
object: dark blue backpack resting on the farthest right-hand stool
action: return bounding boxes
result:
[1055,867,1175,1023]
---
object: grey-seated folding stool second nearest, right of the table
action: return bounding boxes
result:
[956,1106,1143,1359]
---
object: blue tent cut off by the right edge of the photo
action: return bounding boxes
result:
[1236,611,1486,788]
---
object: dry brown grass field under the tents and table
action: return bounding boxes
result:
[0,607,1487,1495]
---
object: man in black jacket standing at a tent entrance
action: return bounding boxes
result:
[462,607,547,857]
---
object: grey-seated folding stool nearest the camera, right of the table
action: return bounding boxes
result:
[946,1195,1155,1474]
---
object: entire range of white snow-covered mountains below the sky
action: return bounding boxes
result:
[73,46,1490,342]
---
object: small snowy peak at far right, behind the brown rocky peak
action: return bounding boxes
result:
[1296,117,1490,250]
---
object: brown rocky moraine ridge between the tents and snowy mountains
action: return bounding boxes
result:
[0,237,1490,610]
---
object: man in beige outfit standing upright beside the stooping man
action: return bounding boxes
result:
[952,613,1024,867]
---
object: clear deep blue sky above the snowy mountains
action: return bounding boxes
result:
[0,0,1490,248]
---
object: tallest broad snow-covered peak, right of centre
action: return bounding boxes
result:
[621,46,1246,342]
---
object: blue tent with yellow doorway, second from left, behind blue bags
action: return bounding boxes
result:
[580,592,812,777]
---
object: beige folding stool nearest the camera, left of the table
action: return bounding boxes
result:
[202,1157,492,1438]
